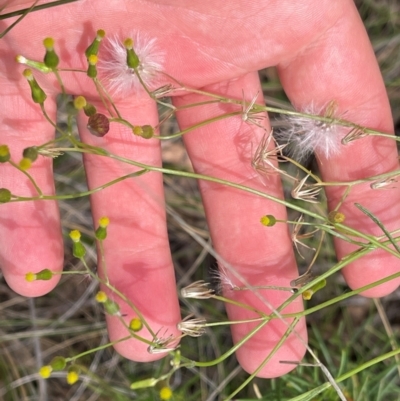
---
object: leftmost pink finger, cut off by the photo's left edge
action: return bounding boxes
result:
[0,83,64,297]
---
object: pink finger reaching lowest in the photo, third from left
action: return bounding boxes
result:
[174,73,307,377]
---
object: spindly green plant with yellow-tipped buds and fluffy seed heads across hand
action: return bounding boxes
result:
[0,25,400,400]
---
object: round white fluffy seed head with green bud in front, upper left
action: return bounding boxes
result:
[98,33,165,96]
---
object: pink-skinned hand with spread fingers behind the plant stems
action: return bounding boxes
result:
[0,0,400,377]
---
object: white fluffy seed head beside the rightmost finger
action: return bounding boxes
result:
[275,105,343,161]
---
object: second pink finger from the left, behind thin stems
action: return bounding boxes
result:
[74,97,180,361]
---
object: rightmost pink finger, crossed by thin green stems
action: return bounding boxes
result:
[279,1,400,297]
